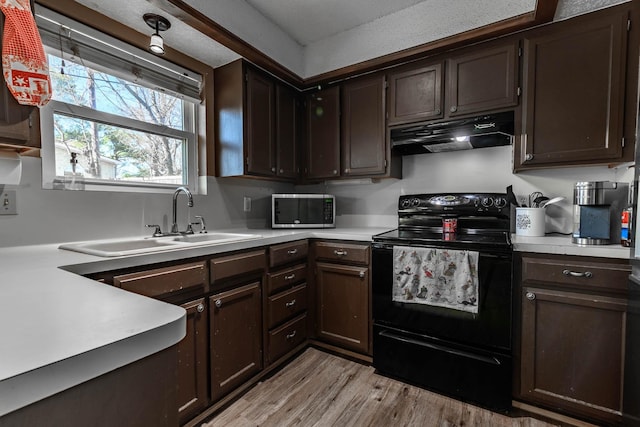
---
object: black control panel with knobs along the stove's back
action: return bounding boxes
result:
[398,193,510,216]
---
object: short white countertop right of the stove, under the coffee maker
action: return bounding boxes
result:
[511,234,631,259]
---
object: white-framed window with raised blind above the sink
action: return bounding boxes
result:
[36,7,200,191]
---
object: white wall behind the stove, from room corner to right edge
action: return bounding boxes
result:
[296,146,633,233]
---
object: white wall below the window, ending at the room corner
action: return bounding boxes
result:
[0,157,292,247]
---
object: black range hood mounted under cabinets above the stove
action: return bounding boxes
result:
[391,111,514,155]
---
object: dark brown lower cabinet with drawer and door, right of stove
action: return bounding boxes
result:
[520,257,628,424]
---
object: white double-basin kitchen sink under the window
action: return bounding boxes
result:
[59,233,262,257]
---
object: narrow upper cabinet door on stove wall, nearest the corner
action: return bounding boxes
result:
[305,86,340,179]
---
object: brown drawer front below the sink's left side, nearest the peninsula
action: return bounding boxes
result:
[113,261,207,297]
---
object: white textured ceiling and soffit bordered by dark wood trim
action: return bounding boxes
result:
[70,0,624,79]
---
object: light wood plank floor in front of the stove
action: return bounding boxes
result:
[202,348,551,427]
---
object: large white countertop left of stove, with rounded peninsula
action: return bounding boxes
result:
[0,228,388,416]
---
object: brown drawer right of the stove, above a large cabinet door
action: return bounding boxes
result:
[522,256,631,292]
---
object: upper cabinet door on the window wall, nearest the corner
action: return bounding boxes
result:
[276,84,302,179]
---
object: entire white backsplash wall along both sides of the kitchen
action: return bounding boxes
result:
[0,146,633,247]
